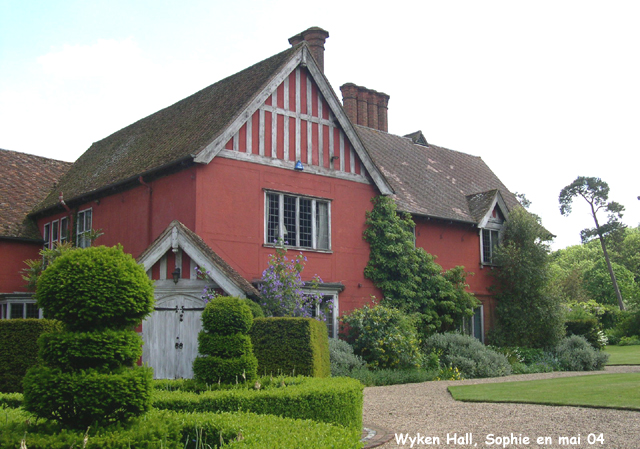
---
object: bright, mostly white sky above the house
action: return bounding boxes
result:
[0,0,640,249]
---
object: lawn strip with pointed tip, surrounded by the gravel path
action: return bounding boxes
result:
[449,373,640,410]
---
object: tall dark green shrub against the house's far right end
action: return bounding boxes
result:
[490,208,565,348]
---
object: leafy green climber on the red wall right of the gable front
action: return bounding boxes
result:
[364,196,478,336]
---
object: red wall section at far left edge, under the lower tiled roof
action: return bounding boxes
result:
[0,239,42,293]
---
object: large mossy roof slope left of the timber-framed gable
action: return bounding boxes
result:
[34,43,306,212]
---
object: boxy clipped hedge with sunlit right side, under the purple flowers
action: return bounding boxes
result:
[249,318,331,377]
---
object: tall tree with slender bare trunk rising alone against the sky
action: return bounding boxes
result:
[558,176,625,310]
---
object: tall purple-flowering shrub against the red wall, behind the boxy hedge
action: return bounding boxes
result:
[260,240,333,321]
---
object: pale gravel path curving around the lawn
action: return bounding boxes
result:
[364,366,640,449]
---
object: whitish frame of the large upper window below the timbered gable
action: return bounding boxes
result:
[264,190,331,252]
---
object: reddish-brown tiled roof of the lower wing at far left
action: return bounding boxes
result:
[0,149,71,239]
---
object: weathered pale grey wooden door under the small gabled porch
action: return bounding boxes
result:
[142,294,204,379]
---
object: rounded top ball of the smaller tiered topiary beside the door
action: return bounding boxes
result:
[202,296,253,335]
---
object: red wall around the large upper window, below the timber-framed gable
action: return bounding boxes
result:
[190,157,381,314]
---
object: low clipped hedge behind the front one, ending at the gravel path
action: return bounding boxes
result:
[152,377,363,430]
